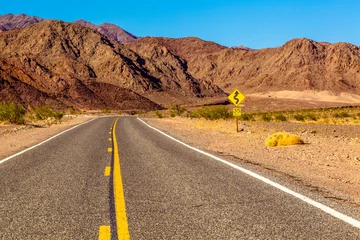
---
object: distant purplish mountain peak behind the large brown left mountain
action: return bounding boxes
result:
[74,20,138,43]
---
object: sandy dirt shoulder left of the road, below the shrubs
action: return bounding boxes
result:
[0,115,96,160]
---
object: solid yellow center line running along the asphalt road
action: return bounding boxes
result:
[113,119,130,240]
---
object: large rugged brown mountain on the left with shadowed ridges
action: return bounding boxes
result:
[0,21,224,109]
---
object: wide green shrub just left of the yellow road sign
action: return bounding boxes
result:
[189,106,232,120]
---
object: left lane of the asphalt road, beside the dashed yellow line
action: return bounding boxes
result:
[0,118,114,240]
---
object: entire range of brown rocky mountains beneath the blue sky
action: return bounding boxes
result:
[0,14,360,108]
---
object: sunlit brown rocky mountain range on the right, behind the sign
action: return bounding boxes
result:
[127,38,360,94]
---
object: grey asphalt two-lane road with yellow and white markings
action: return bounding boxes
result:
[0,117,360,240]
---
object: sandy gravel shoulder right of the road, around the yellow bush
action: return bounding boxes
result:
[144,118,360,209]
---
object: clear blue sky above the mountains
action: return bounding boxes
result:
[0,0,360,49]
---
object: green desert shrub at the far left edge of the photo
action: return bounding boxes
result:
[0,102,26,124]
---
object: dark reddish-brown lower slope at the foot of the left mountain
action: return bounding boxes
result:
[0,59,160,110]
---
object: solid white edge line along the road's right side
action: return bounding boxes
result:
[138,118,360,228]
